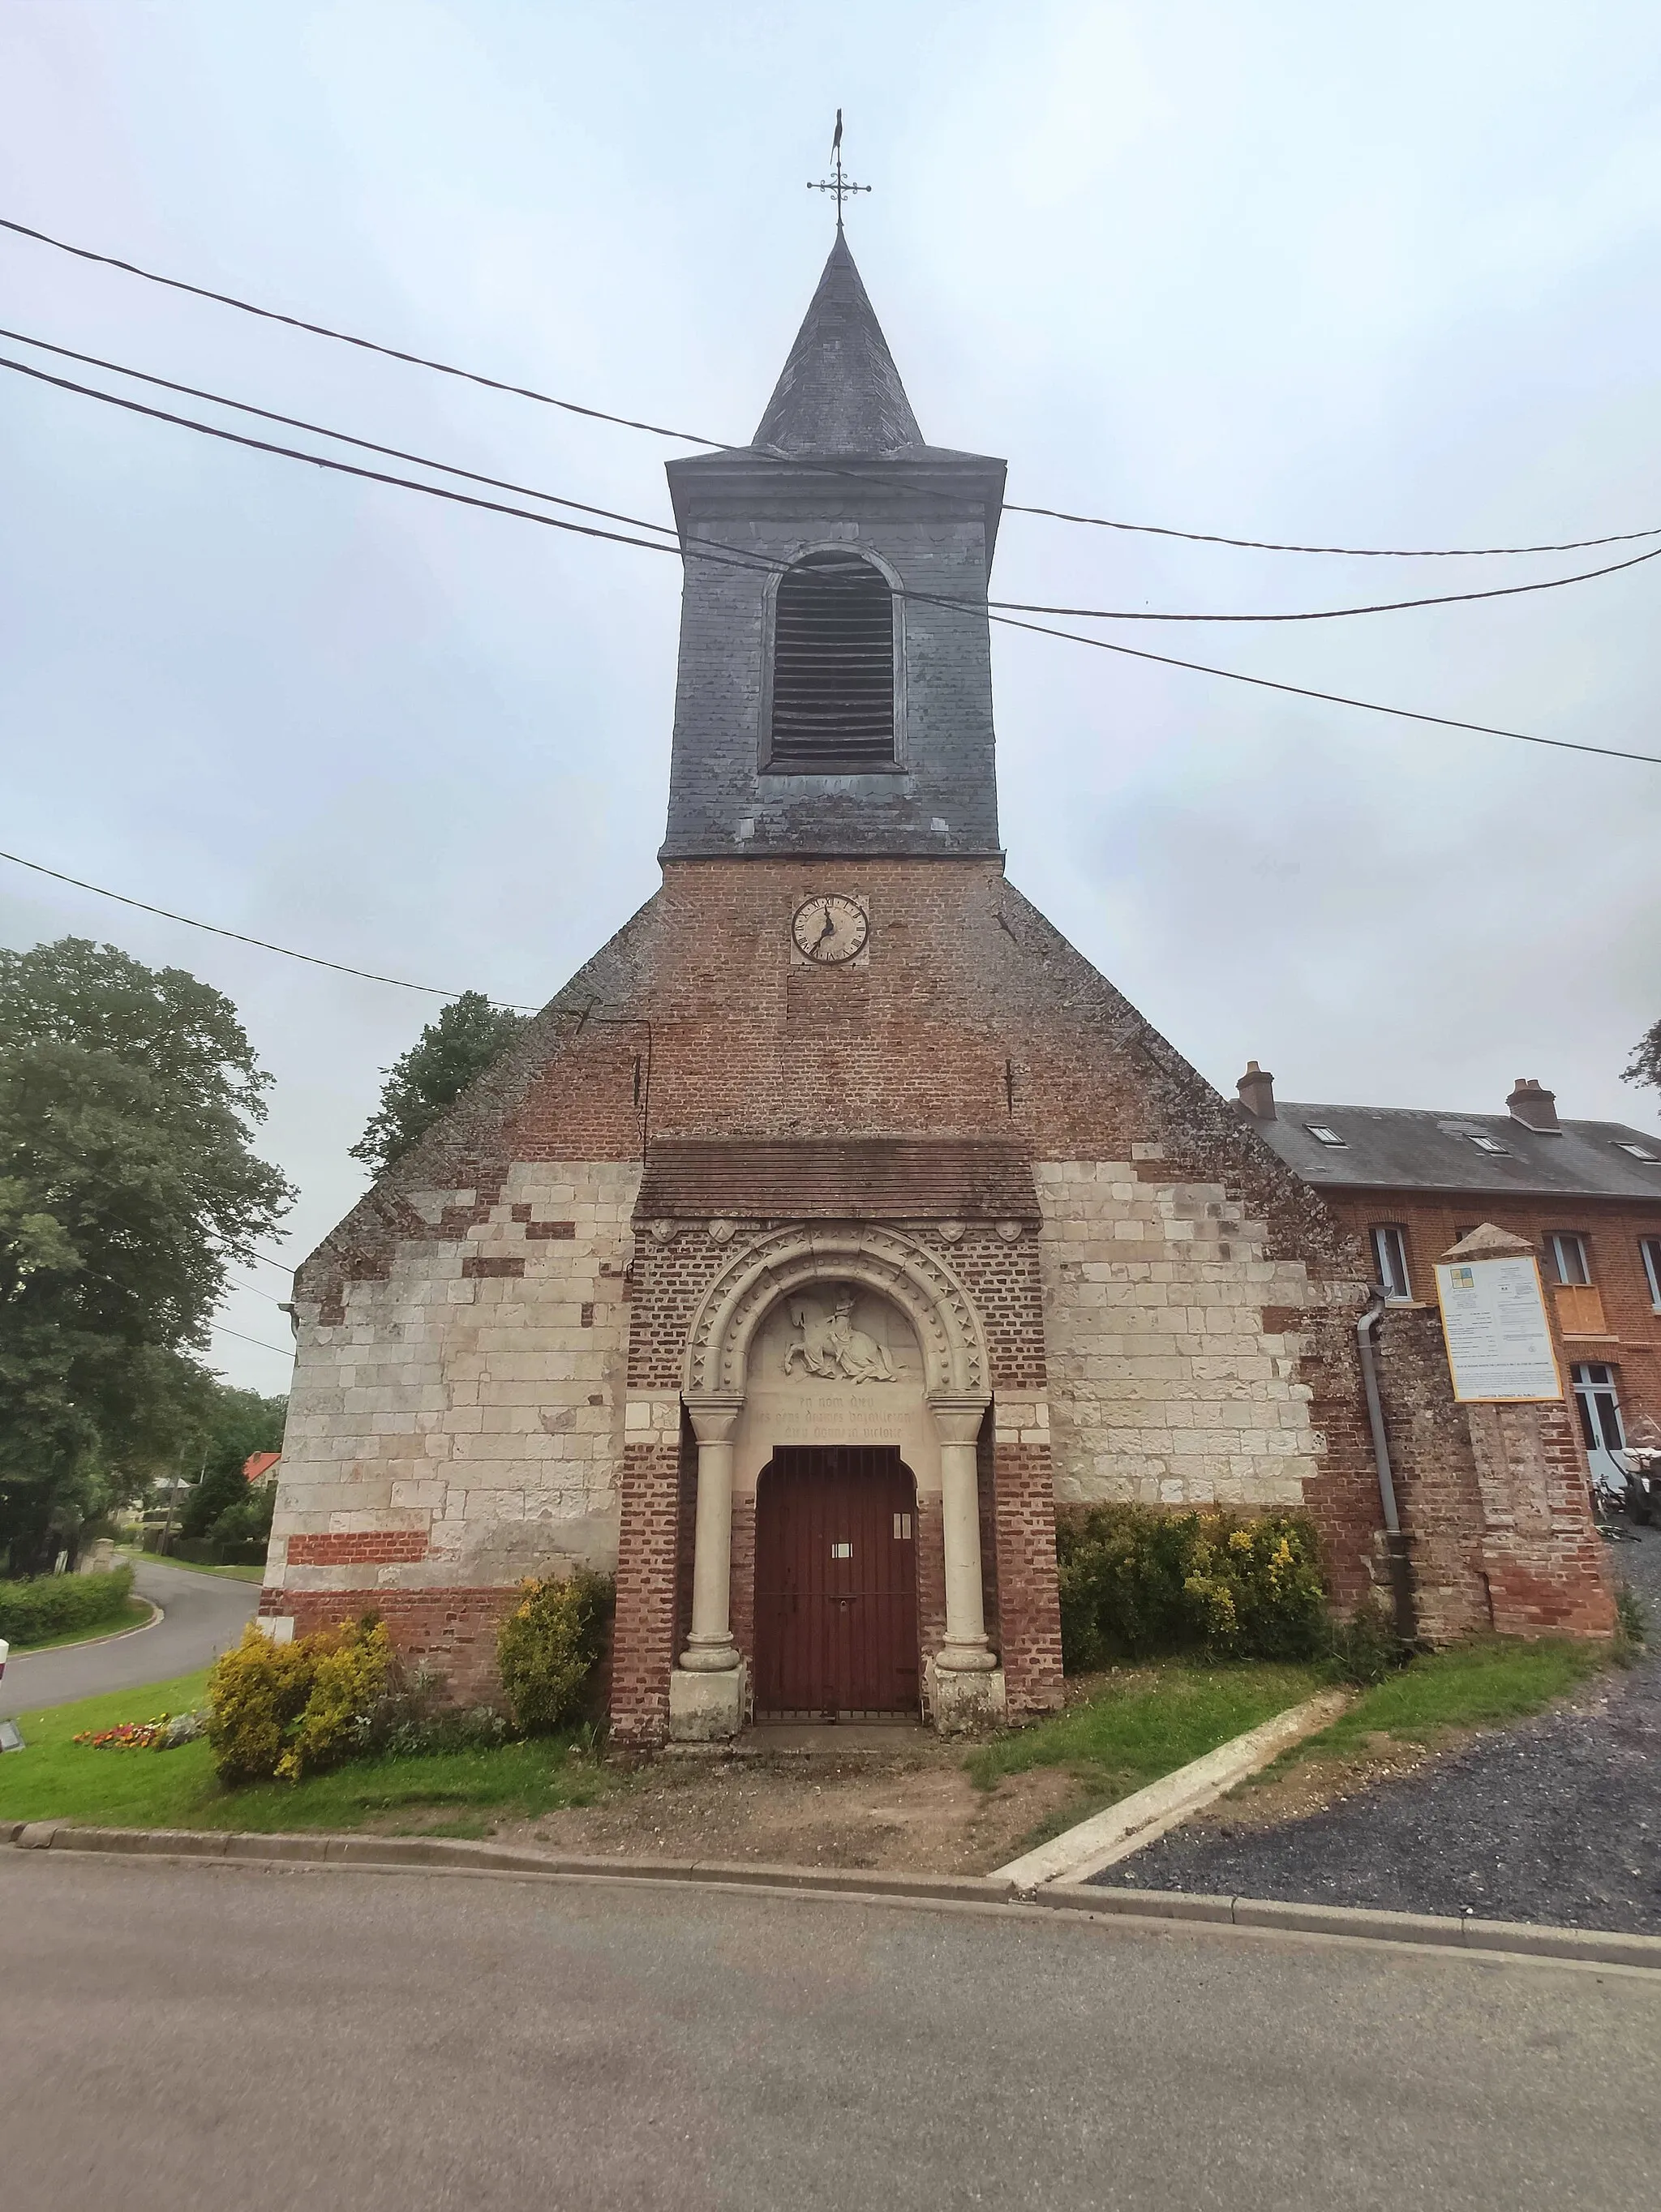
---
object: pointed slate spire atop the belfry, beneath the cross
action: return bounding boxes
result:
[749,230,925,456]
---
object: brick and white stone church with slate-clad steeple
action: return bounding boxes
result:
[261,224,1608,1747]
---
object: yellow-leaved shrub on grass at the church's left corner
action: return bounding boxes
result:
[208,1613,393,1785]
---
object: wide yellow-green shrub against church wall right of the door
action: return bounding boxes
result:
[1058,1504,1327,1674]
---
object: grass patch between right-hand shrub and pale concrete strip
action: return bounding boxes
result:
[967,1659,1332,1850]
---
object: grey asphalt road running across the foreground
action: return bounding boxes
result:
[0,1847,1661,2212]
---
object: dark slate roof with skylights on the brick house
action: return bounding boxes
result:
[1243,1100,1661,1215]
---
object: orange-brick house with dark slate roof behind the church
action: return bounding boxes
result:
[1238,1061,1661,1486]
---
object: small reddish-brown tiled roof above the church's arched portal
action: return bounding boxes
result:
[635,1137,1037,1221]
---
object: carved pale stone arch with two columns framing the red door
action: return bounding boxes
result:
[670,1224,1004,1741]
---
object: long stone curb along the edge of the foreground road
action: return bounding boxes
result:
[13,1820,1661,1973]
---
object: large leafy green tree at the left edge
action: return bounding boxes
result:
[0,938,294,1573]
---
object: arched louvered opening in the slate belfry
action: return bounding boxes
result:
[767,553,894,774]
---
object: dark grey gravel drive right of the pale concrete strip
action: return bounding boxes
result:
[1097,1528,1661,1935]
